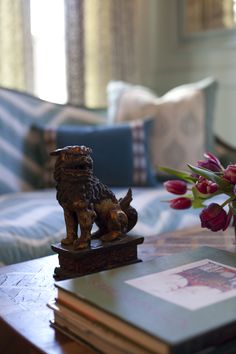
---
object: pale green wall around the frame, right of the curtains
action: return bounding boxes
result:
[150,0,236,147]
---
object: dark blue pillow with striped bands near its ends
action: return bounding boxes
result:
[35,120,156,188]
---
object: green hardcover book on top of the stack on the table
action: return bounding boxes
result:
[56,247,236,354]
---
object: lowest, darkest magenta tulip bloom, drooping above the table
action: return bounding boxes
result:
[200,203,228,231]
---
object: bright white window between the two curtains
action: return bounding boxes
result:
[30,0,67,103]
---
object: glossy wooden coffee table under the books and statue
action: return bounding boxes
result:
[0,228,236,354]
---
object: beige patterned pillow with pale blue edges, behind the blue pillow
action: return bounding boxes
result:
[107,79,218,174]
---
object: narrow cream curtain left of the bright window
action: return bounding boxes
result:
[0,0,33,90]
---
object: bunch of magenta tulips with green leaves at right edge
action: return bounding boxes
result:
[160,152,236,234]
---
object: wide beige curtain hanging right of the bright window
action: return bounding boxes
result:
[65,0,144,107]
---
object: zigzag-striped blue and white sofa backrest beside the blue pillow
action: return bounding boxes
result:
[0,88,105,194]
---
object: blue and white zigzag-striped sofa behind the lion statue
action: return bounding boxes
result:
[0,80,218,264]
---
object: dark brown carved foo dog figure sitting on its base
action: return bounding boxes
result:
[51,145,137,249]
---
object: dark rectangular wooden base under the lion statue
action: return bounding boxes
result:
[51,235,144,280]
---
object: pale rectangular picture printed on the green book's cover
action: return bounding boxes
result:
[126,259,236,310]
